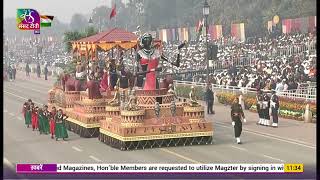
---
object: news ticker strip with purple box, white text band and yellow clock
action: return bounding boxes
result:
[16,164,303,174]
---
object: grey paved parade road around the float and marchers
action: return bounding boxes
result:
[3,71,316,177]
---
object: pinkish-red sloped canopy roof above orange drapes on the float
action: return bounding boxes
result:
[75,28,138,43]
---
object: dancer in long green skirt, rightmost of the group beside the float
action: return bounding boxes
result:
[55,109,68,141]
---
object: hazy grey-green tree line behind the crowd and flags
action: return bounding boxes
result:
[4,0,316,50]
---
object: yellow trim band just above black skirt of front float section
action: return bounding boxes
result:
[100,128,213,141]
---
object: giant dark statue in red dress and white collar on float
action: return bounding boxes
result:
[136,33,183,90]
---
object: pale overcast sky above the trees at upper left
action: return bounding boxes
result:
[3,0,111,23]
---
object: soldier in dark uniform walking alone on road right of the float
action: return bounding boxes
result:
[231,98,246,144]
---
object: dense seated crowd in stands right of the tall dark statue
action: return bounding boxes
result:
[164,33,316,91]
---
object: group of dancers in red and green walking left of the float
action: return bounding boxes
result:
[22,99,68,141]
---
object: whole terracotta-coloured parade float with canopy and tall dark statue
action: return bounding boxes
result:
[49,28,213,150]
